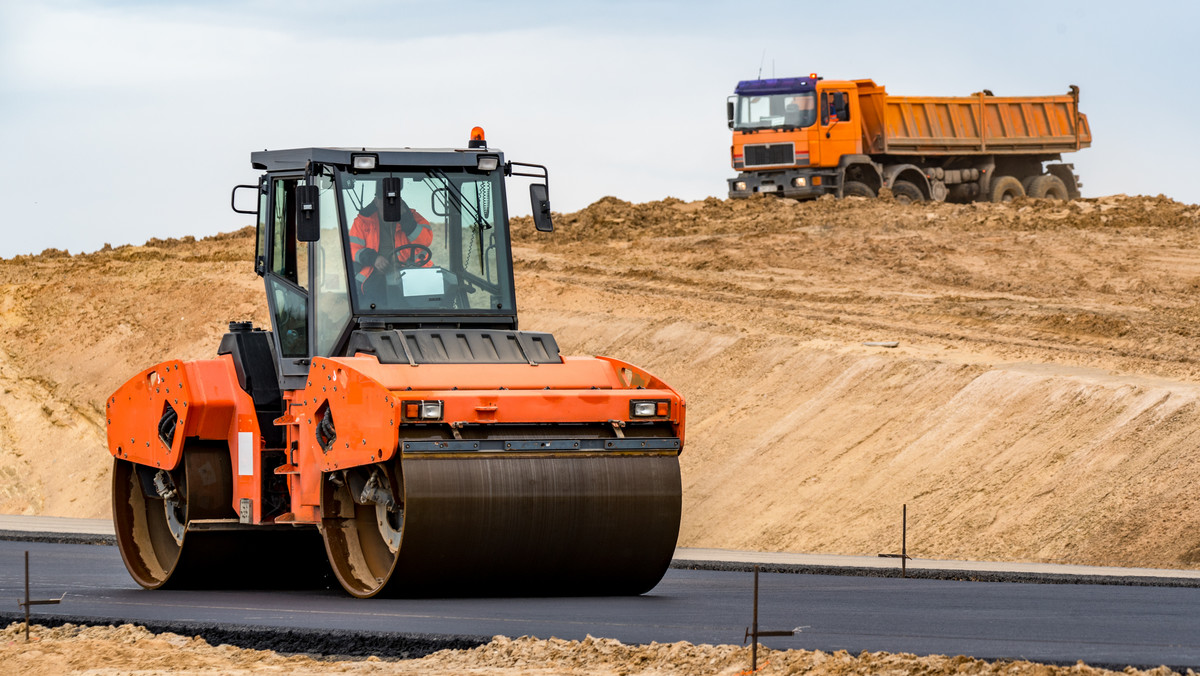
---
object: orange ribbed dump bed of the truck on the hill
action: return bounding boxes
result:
[856,80,1092,155]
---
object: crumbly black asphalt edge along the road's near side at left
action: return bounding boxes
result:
[0,611,492,659]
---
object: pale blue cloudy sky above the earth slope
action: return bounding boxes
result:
[0,0,1200,257]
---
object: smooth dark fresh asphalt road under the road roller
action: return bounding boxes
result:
[0,542,1200,668]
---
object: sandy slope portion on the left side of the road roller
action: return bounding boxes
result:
[0,228,266,516]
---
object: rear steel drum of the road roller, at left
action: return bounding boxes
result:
[113,444,329,590]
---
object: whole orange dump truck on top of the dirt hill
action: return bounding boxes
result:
[726,73,1092,202]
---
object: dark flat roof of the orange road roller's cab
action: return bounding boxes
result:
[250,148,503,172]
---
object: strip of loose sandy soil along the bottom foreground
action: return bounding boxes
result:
[0,623,1192,676]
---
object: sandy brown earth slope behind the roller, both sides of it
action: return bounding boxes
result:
[0,197,1200,567]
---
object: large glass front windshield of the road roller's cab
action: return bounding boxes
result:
[338,169,514,315]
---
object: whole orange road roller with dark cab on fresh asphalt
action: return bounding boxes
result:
[107,127,685,598]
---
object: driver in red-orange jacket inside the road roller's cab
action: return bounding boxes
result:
[350,193,433,291]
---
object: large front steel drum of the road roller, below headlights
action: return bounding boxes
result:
[322,453,683,597]
